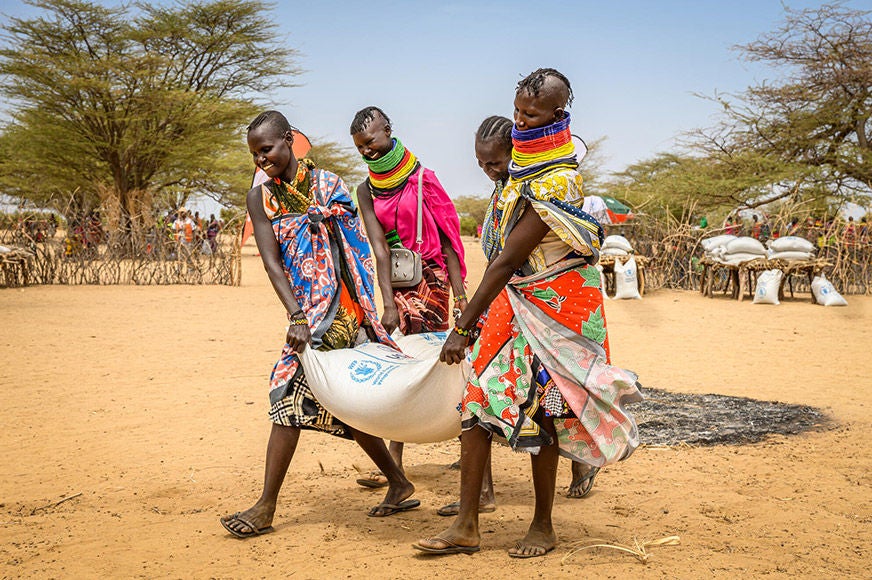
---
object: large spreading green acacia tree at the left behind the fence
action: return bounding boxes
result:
[0,0,299,232]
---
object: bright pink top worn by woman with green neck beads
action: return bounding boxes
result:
[372,169,466,281]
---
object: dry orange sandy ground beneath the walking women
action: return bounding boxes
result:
[0,242,872,578]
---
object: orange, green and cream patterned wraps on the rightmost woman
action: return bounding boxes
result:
[462,168,642,467]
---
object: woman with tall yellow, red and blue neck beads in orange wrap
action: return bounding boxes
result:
[413,69,641,558]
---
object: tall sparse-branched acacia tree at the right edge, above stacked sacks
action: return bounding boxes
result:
[696,4,872,205]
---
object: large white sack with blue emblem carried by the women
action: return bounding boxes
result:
[300,332,468,443]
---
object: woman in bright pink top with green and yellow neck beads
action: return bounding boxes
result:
[351,107,466,487]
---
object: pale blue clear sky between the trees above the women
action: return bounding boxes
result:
[2,0,872,206]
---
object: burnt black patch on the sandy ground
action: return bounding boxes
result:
[628,389,832,446]
